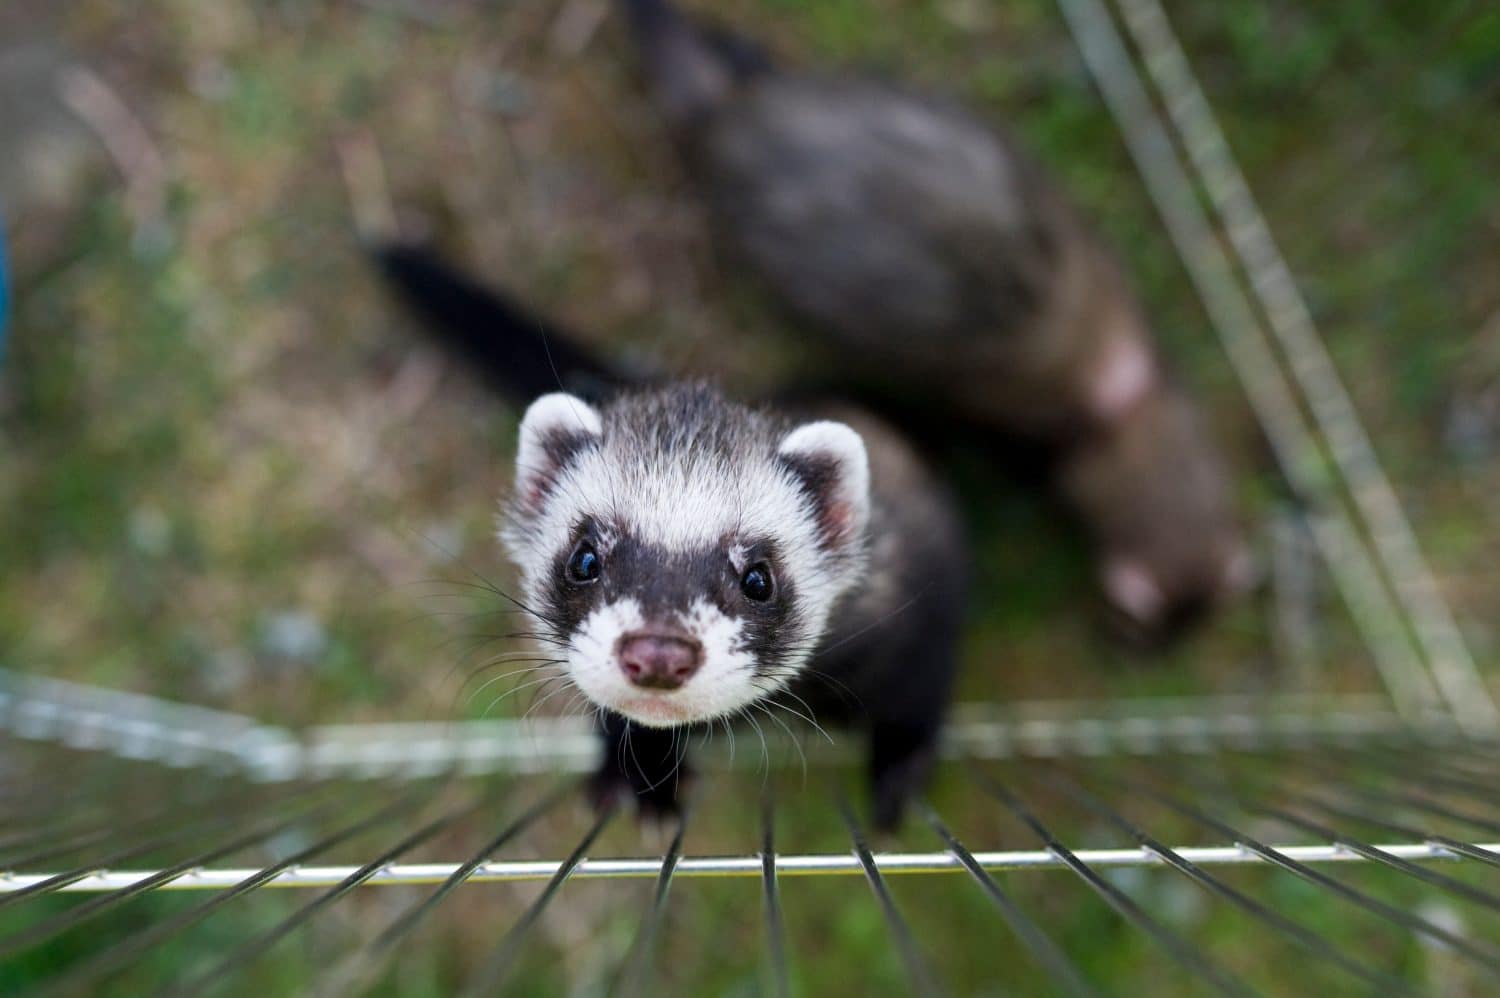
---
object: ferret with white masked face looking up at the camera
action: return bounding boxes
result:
[378,246,968,828]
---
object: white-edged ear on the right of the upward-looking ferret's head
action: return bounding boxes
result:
[777,420,870,551]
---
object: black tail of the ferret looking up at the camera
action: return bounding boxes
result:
[372,243,633,408]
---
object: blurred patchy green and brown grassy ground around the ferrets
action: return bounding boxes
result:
[0,0,1500,990]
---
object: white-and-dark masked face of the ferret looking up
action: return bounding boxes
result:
[501,384,870,726]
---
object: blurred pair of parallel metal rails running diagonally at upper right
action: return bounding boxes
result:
[1059,0,1500,734]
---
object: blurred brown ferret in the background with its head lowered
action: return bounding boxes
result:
[624,0,1250,635]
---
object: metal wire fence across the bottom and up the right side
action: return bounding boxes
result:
[0,0,1500,995]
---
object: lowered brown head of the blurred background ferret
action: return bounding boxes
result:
[1062,389,1256,642]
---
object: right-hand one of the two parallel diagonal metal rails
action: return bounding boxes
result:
[1119,0,1500,732]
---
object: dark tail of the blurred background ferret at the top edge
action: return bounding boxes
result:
[620,0,771,126]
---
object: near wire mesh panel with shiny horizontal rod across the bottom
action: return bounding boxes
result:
[0,716,1500,993]
